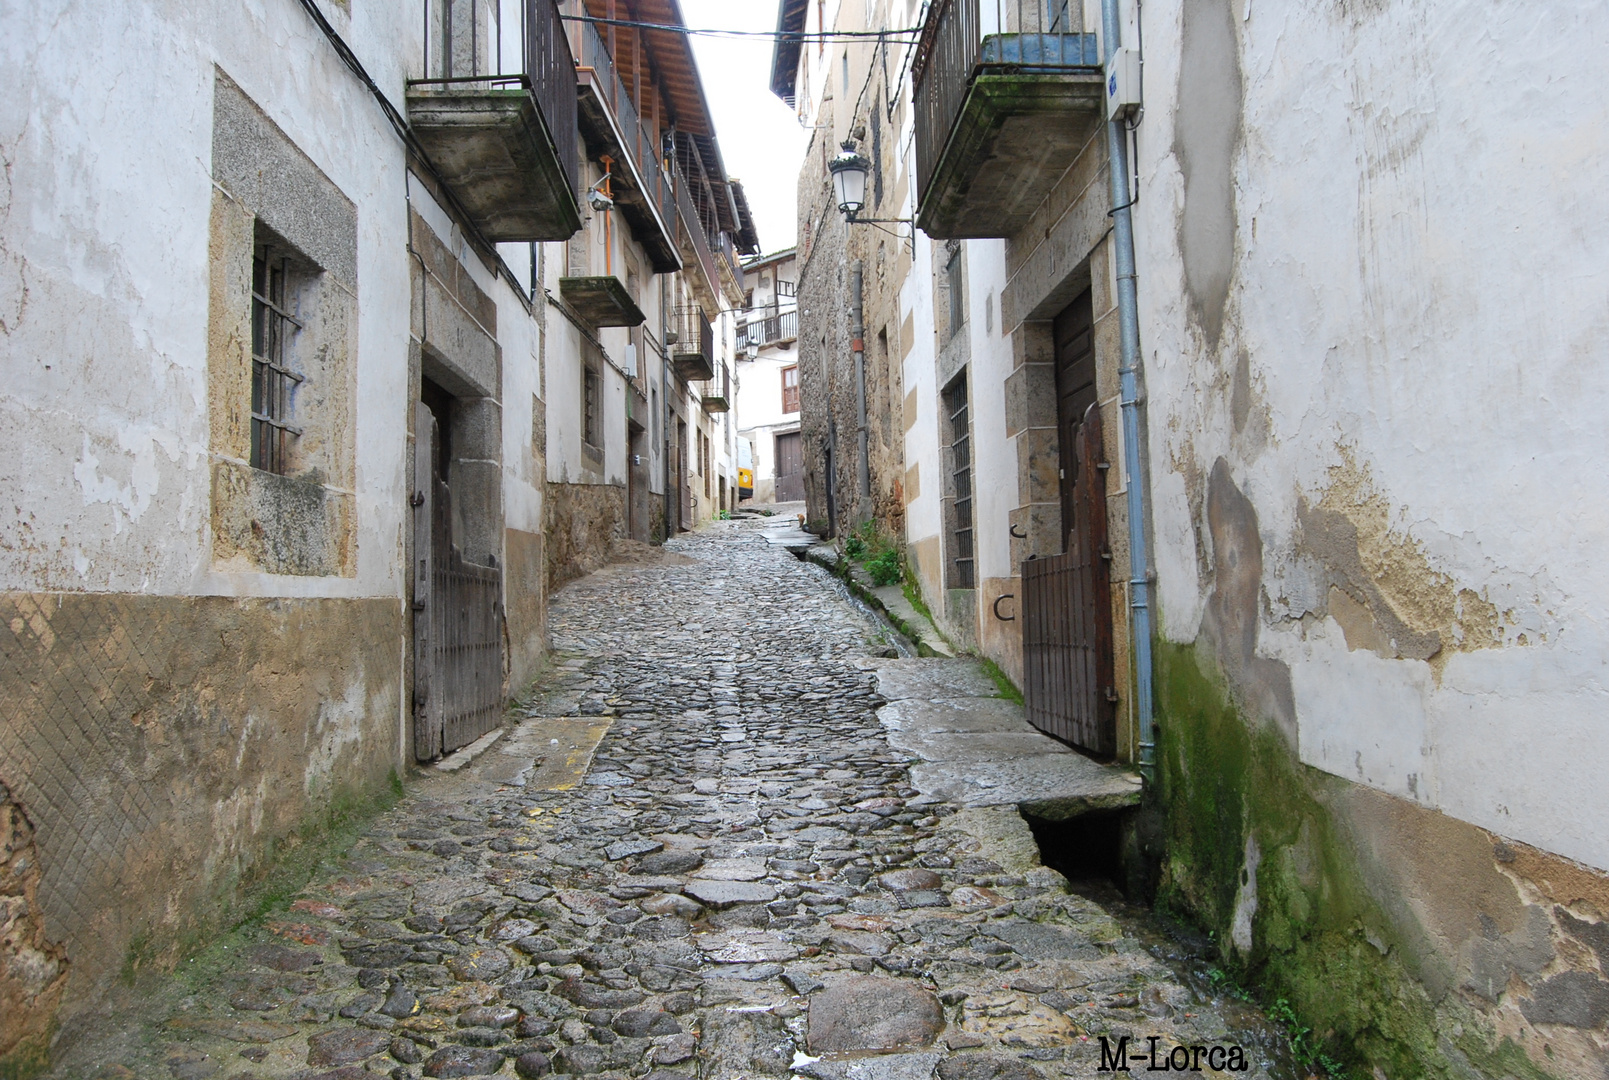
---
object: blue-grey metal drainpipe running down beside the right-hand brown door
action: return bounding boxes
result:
[1101,0,1157,784]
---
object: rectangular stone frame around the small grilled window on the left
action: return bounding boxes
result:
[206,69,357,578]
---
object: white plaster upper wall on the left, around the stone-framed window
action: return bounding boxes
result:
[0,0,418,596]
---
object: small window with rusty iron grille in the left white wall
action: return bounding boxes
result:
[251,241,302,475]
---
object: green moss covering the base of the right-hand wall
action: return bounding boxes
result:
[1155,642,1546,1080]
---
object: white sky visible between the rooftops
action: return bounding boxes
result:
[682,0,809,254]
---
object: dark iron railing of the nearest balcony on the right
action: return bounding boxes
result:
[911,0,1099,198]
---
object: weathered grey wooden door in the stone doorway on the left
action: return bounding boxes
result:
[412,402,504,761]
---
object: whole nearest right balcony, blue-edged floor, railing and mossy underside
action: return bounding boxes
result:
[914,0,1105,240]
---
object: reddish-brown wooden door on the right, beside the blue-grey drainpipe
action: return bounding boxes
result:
[1022,293,1117,756]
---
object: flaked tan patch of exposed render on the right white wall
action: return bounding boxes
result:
[1297,451,1506,678]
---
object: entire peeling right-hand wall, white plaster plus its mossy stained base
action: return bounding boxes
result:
[1130,0,1609,1077]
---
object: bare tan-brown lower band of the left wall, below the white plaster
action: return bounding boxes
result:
[0,592,402,1072]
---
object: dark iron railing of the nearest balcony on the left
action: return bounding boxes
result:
[410,0,581,207]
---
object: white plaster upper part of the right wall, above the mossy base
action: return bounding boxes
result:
[1136,0,1609,868]
